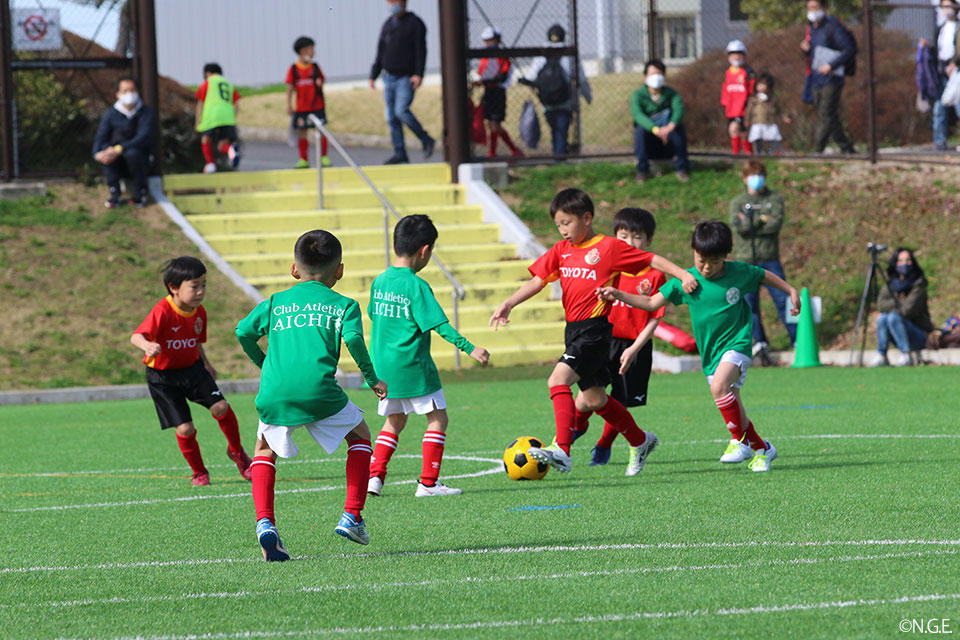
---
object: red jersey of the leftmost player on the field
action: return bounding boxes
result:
[134,296,207,371]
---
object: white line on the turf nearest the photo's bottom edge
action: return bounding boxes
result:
[54,593,960,640]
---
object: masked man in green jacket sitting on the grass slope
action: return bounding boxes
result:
[630,59,690,183]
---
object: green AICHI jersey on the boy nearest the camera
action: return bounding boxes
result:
[236,281,378,427]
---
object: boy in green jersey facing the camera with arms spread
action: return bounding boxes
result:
[598,220,800,471]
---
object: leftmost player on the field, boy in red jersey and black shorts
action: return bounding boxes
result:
[130,256,250,486]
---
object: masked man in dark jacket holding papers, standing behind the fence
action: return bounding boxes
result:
[800,0,857,153]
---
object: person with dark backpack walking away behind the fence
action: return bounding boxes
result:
[519,24,593,156]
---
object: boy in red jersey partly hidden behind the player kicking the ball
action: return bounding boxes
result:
[573,207,666,476]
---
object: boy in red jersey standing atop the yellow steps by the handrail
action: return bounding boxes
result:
[285,36,330,169]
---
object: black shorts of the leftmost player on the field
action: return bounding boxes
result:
[147,360,224,429]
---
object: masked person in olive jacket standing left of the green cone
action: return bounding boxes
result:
[730,160,797,366]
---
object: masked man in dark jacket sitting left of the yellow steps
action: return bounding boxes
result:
[92,76,157,209]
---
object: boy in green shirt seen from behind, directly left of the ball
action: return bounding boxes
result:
[367,215,490,498]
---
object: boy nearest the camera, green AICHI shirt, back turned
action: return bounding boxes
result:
[236,230,387,562]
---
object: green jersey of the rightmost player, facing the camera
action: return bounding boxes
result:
[660,260,765,376]
